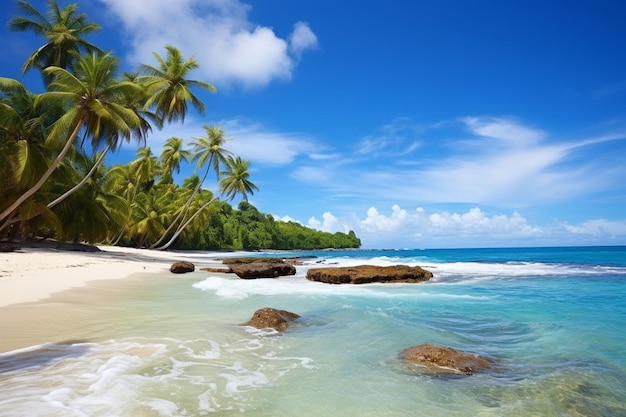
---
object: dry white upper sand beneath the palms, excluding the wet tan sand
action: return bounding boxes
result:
[0,242,221,307]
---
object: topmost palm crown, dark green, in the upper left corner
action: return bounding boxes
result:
[8,0,102,79]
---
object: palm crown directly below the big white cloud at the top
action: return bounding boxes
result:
[137,45,215,123]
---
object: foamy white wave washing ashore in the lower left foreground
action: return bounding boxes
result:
[0,332,310,417]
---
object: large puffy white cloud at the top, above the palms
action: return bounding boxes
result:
[99,0,317,88]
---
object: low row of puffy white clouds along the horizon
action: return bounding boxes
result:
[300,204,626,248]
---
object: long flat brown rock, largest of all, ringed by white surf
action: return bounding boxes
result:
[306,265,433,284]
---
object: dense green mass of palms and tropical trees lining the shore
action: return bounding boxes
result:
[0,0,360,249]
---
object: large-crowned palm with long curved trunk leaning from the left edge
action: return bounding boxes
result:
[0,53,141,226]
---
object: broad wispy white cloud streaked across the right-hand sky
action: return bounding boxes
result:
[300,117,626,208]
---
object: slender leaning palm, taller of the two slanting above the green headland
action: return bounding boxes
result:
[152,125,232,248]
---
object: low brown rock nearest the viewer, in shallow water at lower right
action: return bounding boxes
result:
[399,343,492,374]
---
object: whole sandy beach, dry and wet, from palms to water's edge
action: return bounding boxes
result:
[0,243,228,353]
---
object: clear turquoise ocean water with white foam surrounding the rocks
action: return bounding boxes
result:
[0,246,626,417]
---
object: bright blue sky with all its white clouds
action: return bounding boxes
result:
[0,0,626,248]
